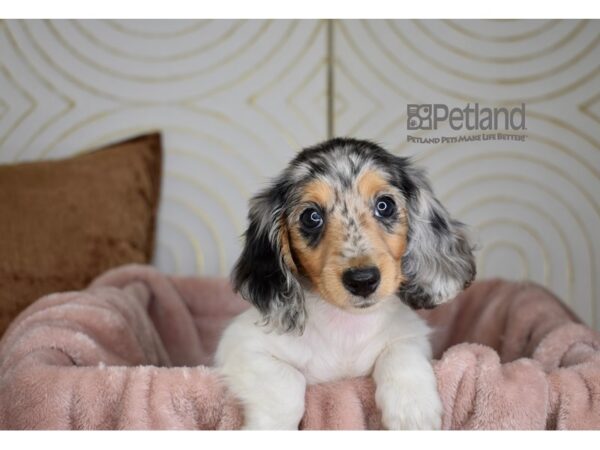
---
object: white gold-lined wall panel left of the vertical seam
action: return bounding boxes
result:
[0,20,327,275]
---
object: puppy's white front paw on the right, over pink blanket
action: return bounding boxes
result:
[375,383,442,430]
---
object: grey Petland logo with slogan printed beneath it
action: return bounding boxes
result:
[406,103,527,144]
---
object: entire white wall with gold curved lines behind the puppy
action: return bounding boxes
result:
[0,20,600,327]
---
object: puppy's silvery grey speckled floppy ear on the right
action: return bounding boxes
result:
[396,158,476,309]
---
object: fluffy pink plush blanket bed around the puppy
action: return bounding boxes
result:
[0,265,600,429]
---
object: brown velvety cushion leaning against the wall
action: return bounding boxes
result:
[0,133,162,336]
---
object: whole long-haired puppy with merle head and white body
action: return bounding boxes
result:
[215,138,475,430]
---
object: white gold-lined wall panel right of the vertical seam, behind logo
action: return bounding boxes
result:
[333,20,600,327]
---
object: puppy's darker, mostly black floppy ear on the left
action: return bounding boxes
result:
[231,181,306,333]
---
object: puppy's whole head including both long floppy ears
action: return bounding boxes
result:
[232,139,475,331]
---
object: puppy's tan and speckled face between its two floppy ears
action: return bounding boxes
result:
[284,167,408,310]
